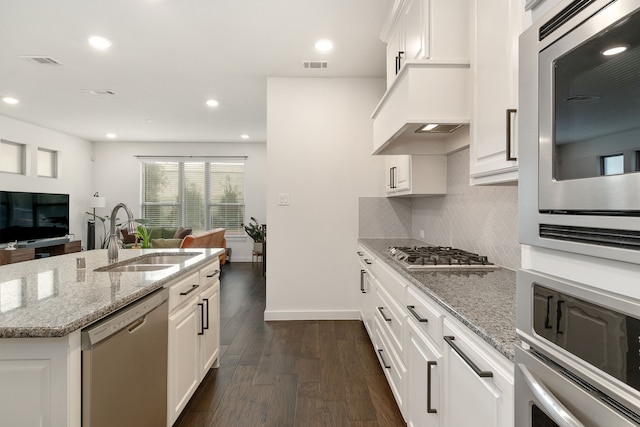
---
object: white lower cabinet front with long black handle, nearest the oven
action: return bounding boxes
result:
[442,319,514,427]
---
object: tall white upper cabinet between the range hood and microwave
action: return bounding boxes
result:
[470,0,524,185]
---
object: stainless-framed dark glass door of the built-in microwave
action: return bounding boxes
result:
[539,0,640,212]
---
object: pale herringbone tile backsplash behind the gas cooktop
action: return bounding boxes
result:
[359,149,520,270]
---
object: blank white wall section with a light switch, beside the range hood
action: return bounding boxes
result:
[265,78,385,320]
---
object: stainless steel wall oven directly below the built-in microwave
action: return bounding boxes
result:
[515,270,640,427]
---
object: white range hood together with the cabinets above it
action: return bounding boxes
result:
[372,0,470,154]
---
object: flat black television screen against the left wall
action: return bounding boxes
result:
[0,191,69,243]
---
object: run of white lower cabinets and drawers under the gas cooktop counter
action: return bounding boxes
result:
[360,251,515,427]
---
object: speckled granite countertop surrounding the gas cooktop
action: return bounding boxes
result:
[359,239,517,361]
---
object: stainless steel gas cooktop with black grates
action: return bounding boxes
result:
[387,246,498,270]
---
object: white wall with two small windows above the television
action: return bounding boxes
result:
[0,116,93,247]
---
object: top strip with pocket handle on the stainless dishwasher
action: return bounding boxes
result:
[81,289,169,350]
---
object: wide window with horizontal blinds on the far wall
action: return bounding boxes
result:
[142,160,244,236]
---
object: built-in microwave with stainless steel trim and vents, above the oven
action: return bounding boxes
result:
[519,0,640,263]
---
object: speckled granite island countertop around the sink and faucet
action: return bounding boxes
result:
[0,249,223,338]
